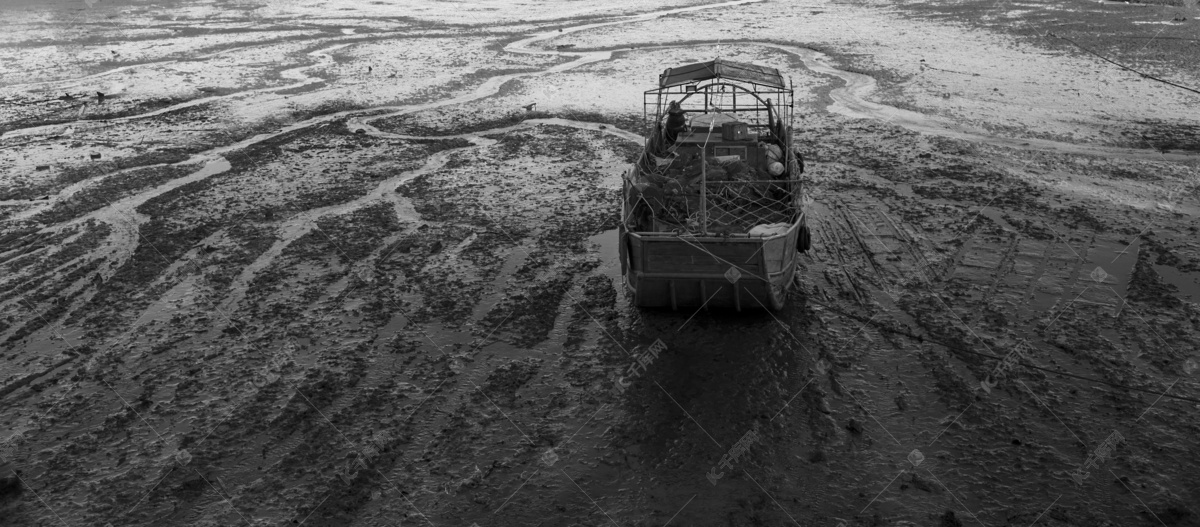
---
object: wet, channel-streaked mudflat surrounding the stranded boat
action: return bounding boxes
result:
[0,0,1200,527]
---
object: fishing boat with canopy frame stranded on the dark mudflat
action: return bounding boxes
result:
[618,59,811,311]
